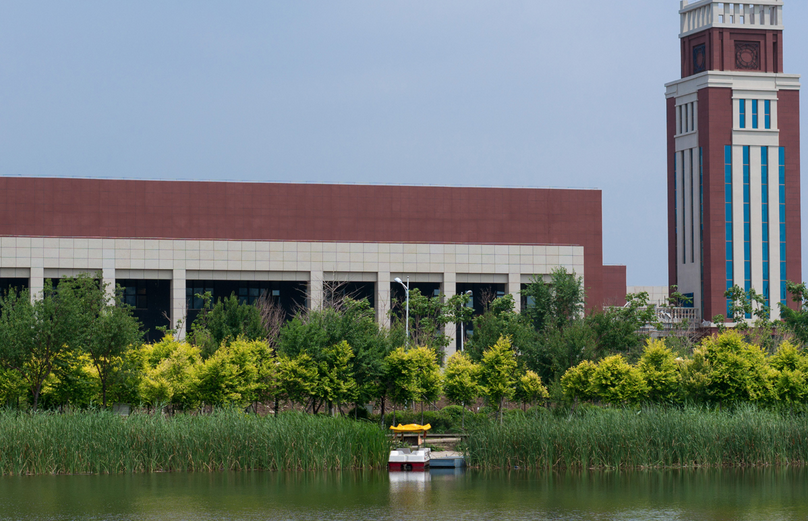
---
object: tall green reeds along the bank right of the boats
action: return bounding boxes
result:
[467,406,808,469]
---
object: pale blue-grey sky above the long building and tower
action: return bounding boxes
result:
[0,0,808,286]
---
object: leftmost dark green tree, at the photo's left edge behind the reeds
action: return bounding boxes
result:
[0,276,98,410]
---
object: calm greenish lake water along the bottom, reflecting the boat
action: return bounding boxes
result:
[0,469,808,521]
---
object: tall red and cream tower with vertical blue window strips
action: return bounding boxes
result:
[666,0,802,320]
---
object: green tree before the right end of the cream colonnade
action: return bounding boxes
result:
[522,267,586,331]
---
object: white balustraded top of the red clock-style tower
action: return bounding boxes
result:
[679,0,783,37]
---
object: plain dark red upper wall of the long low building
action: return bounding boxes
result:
[0,178,603,307]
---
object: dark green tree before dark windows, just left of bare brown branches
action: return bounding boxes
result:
[189,293,267,358]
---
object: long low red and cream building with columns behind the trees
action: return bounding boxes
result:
[0,178,625,354]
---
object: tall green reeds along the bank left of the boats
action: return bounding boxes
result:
[0,411,389,475]
